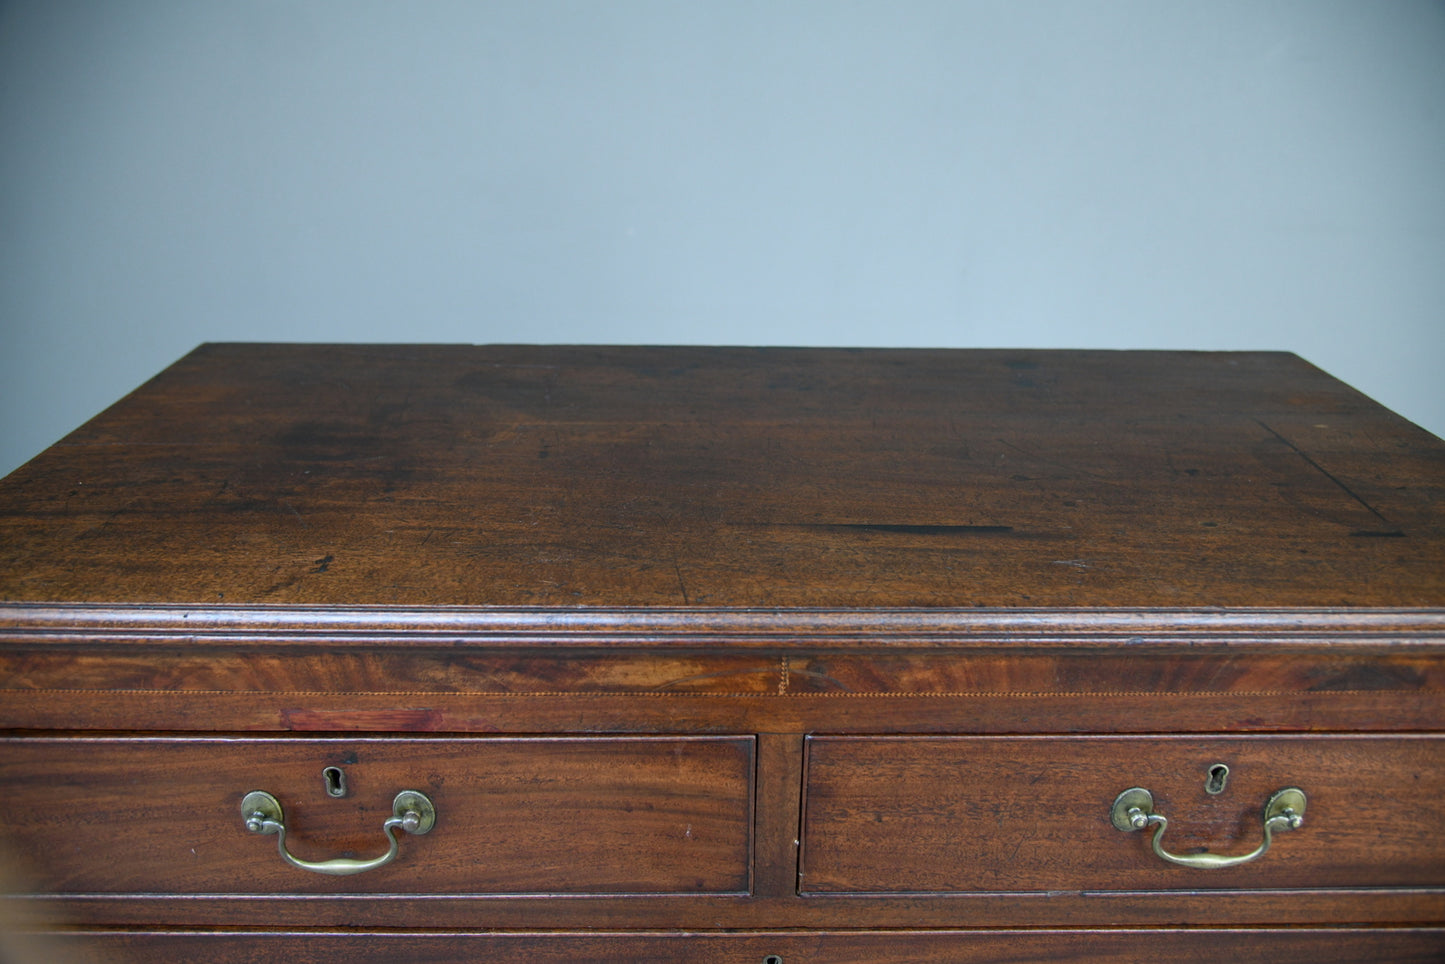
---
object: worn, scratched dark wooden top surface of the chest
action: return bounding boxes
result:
[0,344,1445,613]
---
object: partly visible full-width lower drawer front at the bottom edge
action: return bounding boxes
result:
[36,928,1445,964]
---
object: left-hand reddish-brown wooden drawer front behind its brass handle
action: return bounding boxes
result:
[0,737,754,895]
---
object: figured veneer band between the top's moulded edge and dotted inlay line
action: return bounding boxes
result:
[11,639,1445,695]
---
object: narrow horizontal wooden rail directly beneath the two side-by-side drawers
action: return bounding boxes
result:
[19,890,1445,932]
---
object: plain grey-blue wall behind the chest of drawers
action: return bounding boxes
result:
[0,0,1445,471]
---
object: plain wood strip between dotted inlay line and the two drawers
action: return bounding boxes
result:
[3,689,1445,734]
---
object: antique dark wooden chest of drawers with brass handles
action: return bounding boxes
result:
[0,345,1445,964]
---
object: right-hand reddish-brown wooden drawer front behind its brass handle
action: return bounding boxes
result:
[799,734,1445,895]
